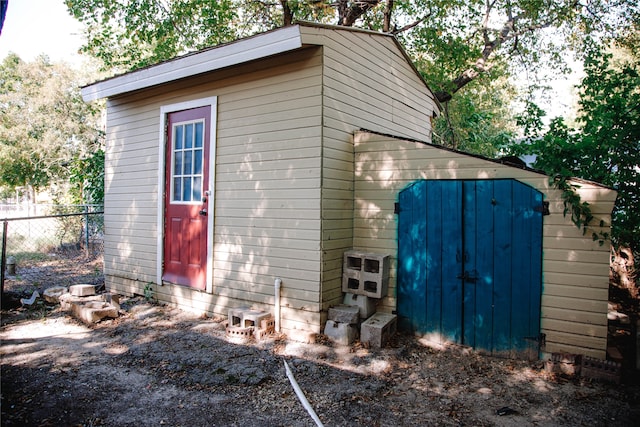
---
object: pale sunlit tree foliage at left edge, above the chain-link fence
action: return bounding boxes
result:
[0,54,104,204]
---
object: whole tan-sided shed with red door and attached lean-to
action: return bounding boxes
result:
[82,23,615,358]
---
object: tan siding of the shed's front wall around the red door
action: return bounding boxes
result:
[105,48,322,342]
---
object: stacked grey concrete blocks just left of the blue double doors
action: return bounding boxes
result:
[324,251,396,347]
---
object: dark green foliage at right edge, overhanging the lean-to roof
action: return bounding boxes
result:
[514,44,640,251]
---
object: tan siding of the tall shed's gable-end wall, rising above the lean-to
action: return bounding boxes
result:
[300,26,437,310]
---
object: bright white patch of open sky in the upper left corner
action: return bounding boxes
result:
[0,0,82,65]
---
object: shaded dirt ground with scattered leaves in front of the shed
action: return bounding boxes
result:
[0,297,640,427]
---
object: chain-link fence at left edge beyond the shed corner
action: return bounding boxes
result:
[0,205,104,305]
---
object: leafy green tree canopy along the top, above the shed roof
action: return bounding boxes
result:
[66,0,638,102]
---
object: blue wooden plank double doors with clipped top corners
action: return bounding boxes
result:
[397,179,543,359]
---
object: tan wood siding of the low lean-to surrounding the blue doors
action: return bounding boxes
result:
[354,132,616,359]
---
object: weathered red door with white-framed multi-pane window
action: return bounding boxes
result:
[162,107,211,289]
